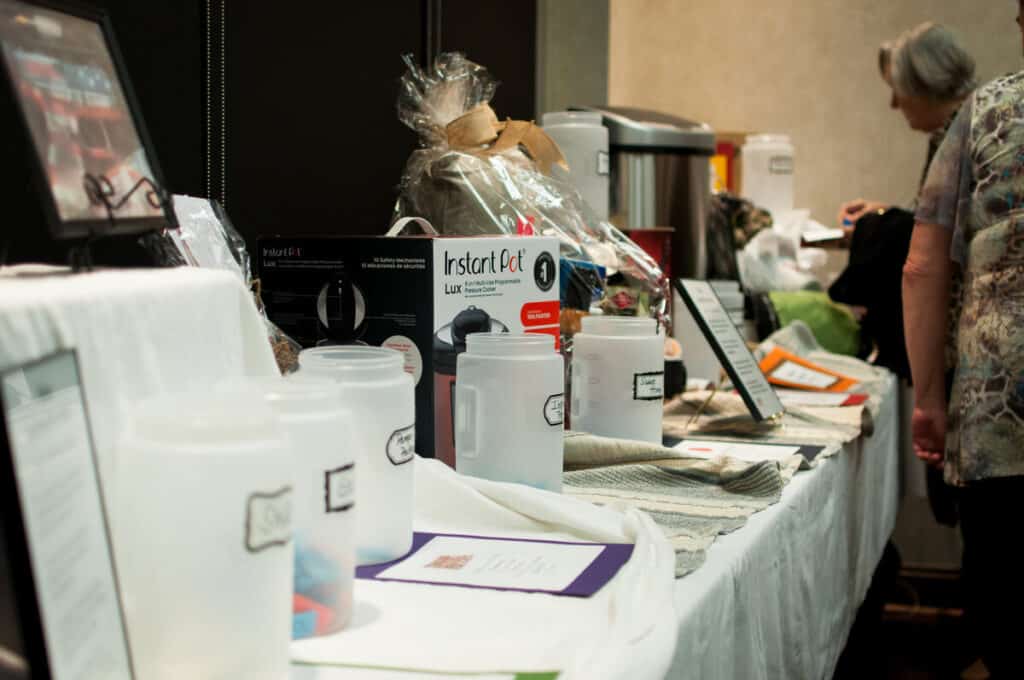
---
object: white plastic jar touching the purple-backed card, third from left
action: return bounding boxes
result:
[299,345,416,564]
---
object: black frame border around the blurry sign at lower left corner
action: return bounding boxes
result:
[0,348,137,680]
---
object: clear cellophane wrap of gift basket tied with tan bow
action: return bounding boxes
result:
[392,53,670,335]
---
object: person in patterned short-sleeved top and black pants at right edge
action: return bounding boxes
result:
[903,2,1024,678]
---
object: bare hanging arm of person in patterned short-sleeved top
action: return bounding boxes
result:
[903,222,952,464]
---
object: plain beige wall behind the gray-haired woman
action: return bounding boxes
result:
[608,0,1024,224]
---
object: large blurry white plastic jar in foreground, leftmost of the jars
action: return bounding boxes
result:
[115,385,294,680]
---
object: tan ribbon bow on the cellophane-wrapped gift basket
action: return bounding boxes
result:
[444,103,569,174]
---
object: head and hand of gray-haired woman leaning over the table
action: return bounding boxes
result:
[839,22,977,225]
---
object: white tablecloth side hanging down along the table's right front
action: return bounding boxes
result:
[666,380,900,680]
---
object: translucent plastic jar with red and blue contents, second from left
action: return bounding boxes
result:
[261,376,355,639]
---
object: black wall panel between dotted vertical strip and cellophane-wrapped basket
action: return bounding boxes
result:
[223,0,424,245]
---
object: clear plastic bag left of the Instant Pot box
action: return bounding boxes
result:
[139,195,302,374]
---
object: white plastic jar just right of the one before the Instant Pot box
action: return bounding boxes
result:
[572,316,663,443]
